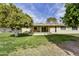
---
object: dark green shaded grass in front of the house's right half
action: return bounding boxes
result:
[46,34,79,44]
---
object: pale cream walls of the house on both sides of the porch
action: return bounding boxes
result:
[22,26,79,34]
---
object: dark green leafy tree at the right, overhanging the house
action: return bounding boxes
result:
[62,3,79,27]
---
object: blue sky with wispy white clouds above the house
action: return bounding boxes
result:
[15,3,65,23]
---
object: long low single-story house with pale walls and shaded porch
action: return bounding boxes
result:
[22,24,79,34]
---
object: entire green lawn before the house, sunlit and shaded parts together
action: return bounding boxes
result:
[0,33,79,55]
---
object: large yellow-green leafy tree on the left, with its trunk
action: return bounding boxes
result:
[0,4,33,35]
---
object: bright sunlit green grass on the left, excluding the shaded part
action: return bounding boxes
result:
[0,33,48,55]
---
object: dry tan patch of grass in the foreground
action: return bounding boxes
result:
[9,43,74,56]
